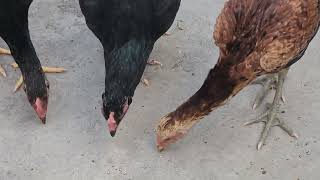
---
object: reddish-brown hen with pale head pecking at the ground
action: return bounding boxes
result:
[157,0,320,150]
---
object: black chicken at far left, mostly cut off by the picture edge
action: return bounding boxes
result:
[0,0,65,123]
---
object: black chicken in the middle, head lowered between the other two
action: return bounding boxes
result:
[79,0,180,136]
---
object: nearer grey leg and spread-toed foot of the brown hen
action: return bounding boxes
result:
[245,69,298,150]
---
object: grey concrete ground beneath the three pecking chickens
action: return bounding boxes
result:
[0,0,320,180]
